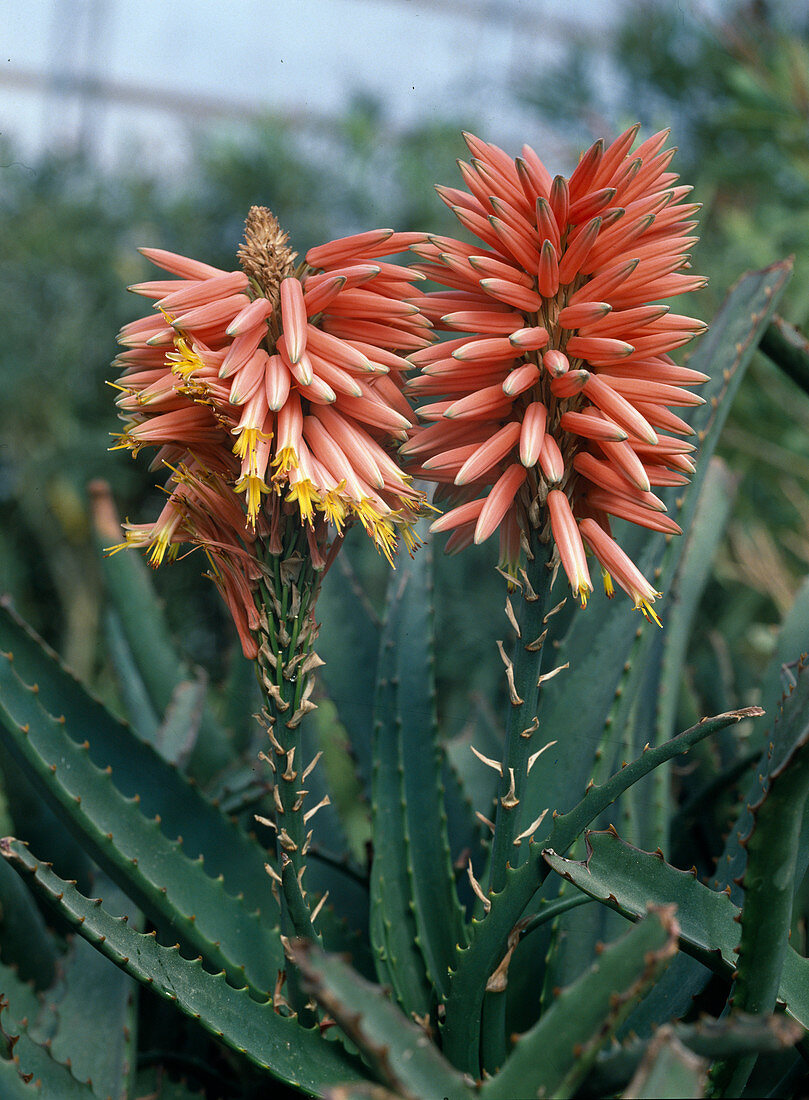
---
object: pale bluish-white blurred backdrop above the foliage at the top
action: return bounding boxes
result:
[0,0,654,171]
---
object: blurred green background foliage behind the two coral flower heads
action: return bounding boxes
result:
[0,2,809,734]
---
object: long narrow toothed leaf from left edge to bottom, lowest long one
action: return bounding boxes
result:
[0,838,363,1095]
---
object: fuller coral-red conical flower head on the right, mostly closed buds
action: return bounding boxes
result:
[403,127,707,615]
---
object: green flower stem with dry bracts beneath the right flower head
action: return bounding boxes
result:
[489,531,553,893]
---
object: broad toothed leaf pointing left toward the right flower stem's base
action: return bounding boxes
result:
[543,829,809,1026]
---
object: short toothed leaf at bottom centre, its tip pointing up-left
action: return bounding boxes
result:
[292,941,474,1100]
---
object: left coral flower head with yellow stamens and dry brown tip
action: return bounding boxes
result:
[113,207,431,656]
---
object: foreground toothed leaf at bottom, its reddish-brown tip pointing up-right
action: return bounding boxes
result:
[480,906,678,1100]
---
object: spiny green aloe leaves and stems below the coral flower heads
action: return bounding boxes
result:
[0,122,809,1100]
